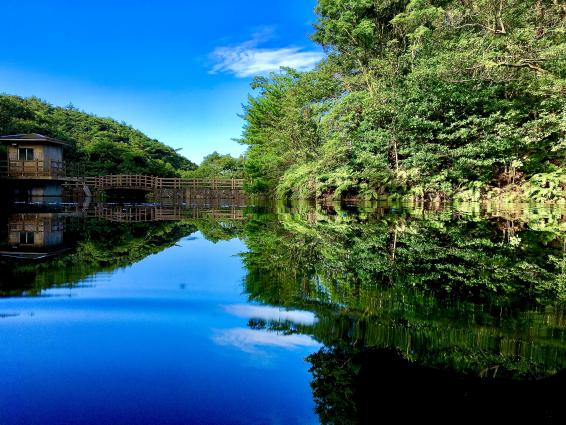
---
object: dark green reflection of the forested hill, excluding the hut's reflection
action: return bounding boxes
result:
[0,217,246,296]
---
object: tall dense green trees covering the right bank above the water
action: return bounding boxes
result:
[241,0,566,202]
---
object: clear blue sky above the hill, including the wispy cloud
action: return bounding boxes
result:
[0,0,322,162]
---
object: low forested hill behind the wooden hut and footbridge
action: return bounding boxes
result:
[0,95,197,177]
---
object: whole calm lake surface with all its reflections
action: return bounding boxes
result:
[0,204,566,425]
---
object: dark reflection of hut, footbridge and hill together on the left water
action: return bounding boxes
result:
[0,204,247,296]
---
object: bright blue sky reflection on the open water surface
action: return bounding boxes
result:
[0,235,319,425]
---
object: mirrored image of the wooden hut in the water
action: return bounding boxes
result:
[0,213,65,259]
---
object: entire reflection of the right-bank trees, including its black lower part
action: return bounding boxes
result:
[243,207,566,424]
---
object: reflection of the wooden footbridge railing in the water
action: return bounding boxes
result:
[89,206,244,223]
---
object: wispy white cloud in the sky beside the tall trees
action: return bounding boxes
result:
[210,31,324,78]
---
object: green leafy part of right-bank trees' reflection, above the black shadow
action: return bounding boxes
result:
[243,205,566,372]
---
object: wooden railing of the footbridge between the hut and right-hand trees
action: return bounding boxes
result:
[84,174,244,191]
